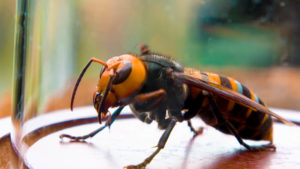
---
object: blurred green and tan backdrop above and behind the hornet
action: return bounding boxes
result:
[0,0,300,117]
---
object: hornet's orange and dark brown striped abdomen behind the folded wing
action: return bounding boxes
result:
[184,69,273,141]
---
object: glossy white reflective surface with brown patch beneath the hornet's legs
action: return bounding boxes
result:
[18,108,300,169]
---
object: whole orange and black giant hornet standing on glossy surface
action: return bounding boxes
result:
[60,45,293,168]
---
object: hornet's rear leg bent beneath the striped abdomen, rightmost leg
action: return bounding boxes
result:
[207,94,276,151]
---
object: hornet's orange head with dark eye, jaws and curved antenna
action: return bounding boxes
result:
[71,54,146,123]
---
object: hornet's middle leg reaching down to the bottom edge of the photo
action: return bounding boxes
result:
[124,119,176,169]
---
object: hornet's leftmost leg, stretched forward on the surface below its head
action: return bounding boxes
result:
[59,106,124,142]
